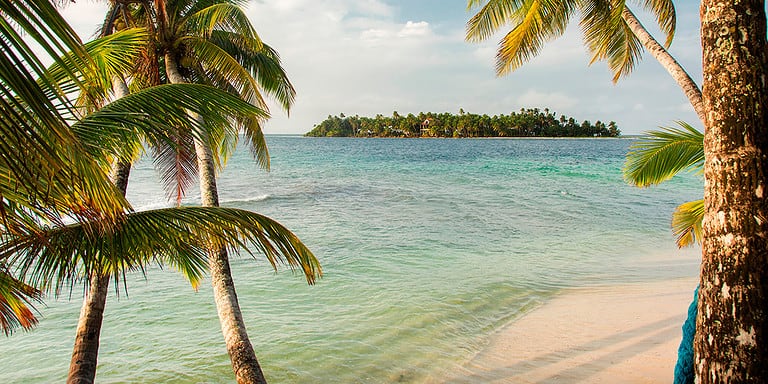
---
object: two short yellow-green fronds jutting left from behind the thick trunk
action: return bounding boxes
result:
[624,121,704,247]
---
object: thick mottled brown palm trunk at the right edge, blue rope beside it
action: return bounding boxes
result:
[694,0,768,383]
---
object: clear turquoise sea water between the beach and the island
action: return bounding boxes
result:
[0,136,702,383]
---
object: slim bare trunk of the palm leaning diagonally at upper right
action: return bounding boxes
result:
[621,7,706,124]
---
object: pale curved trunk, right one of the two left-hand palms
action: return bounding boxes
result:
[165,54,266,384]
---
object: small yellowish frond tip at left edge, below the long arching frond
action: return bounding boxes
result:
[0,264,41,336]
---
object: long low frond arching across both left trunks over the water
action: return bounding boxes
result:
[0,207,322,293]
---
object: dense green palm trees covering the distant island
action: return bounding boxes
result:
[306,108,621,137]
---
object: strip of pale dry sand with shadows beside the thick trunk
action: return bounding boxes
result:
[440,278,697,384]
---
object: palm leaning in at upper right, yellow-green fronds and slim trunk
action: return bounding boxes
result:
[467,0,705,122]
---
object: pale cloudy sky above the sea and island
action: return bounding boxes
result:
[63,0,701,134]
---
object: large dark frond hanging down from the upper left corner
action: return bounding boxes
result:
[0,0,128,229]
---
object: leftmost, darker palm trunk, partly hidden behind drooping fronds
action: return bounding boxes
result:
[67,79,131,384]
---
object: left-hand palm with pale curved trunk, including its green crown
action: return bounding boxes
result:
[144,0,295,383]
